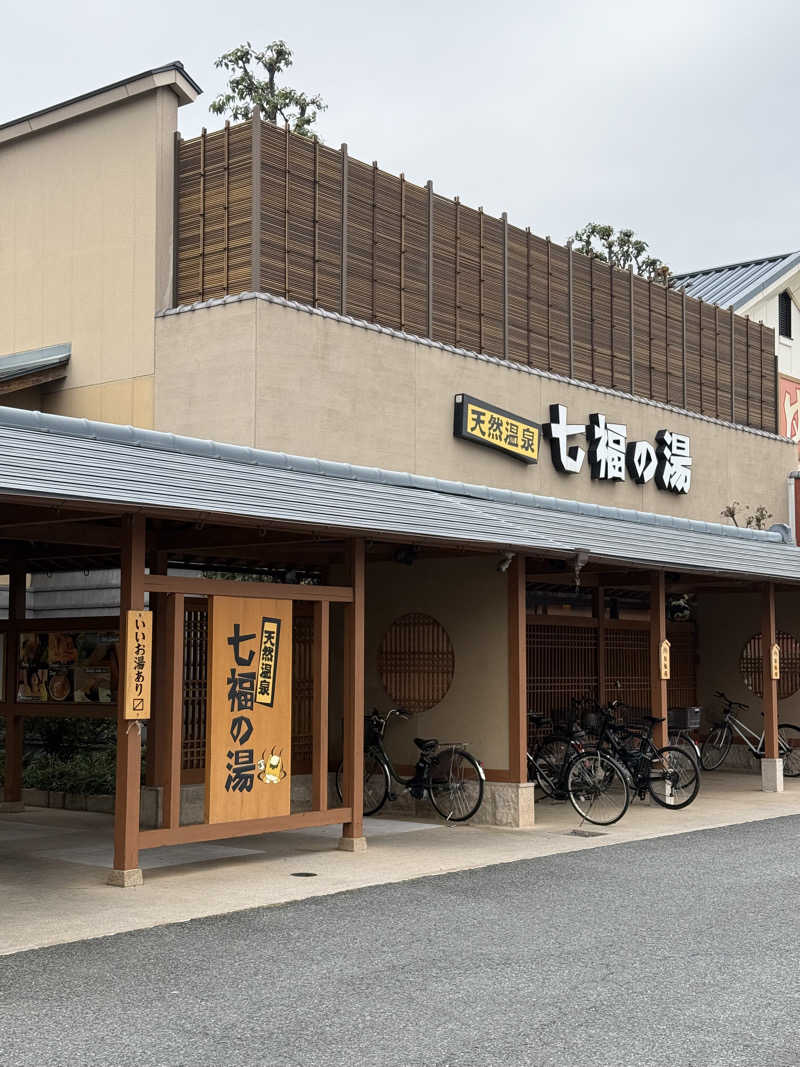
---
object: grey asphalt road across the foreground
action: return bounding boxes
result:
[0,817,800,1067]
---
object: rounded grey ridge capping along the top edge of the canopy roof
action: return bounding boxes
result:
[0,407,784,542]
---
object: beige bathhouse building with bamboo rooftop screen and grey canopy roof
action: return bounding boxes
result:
[0,64,800,880]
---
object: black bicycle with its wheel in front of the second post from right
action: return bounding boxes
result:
[583,701,700,810]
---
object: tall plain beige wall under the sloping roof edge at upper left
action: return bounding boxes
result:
[0,87,178,427]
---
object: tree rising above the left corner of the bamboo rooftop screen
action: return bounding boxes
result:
[208,41,327,137]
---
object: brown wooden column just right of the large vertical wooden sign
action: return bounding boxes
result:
[340,539,366,851]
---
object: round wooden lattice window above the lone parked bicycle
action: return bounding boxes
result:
[378,611,455,712]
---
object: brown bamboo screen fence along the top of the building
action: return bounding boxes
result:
[174,117,778,431]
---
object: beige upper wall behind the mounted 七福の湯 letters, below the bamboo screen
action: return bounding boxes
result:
[155,300,795,522]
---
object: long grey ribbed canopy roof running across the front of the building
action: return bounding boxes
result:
[0,408,800,582]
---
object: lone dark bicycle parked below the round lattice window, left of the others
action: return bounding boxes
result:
[336,707,485,823]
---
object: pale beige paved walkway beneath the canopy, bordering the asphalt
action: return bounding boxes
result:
[0,773,800,955]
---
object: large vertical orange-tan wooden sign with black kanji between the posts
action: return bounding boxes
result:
[206,596,292,823]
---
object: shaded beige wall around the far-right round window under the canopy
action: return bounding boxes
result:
[698,592,800,733]
